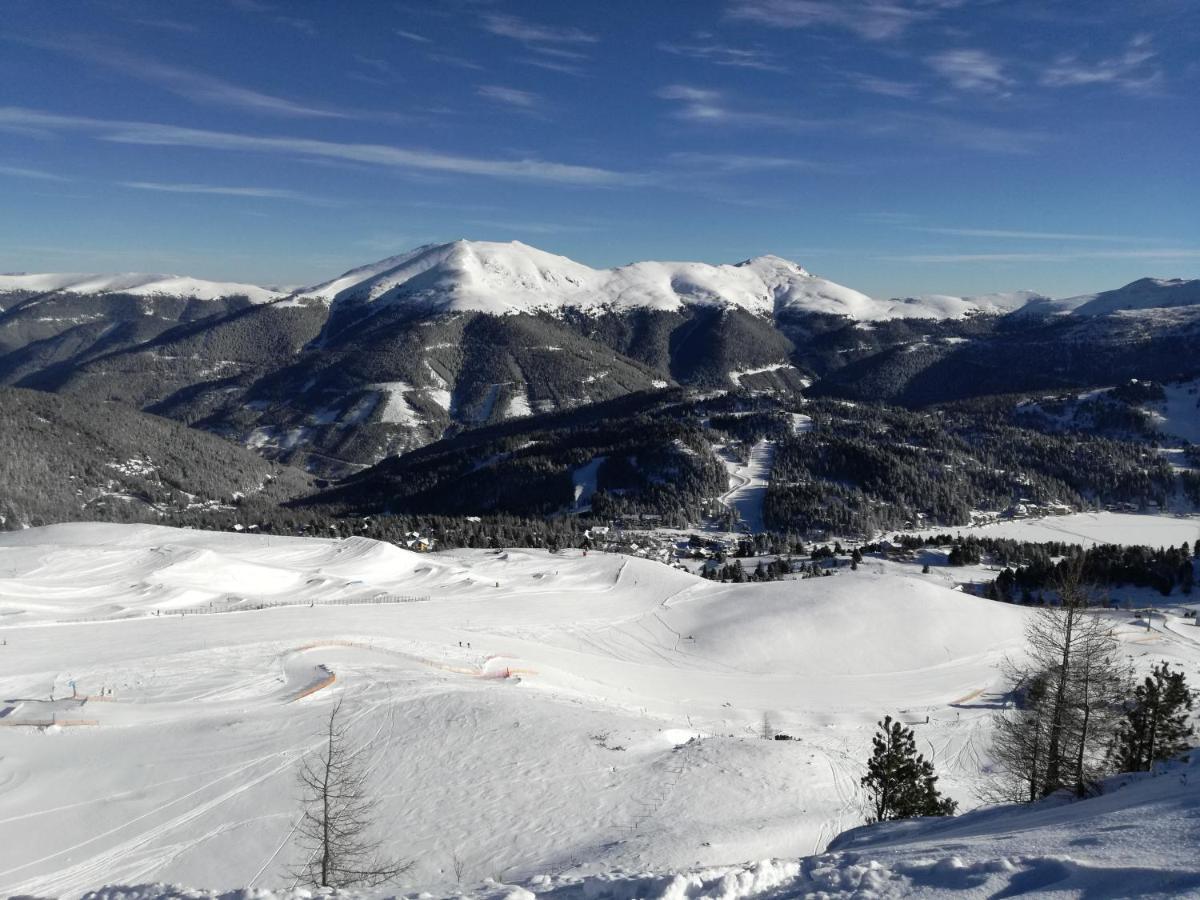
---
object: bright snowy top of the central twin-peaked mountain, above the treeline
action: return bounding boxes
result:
[299,240,1037,322]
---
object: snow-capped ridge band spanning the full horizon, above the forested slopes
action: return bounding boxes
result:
[0,239,1200,324]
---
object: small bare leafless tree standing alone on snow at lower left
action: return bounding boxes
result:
[294,701,412,888]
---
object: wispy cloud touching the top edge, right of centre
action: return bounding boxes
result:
[728,0,956,41]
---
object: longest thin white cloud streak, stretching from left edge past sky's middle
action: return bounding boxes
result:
[0,107,644,187]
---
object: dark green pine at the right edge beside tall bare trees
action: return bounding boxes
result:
[1115,662,1194,772]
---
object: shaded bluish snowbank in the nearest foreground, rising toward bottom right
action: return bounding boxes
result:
[85,754,1200,900]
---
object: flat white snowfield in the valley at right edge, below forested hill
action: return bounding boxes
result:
[901,512,1200,547]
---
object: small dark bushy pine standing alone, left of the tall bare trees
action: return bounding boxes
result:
[862,715,958,824]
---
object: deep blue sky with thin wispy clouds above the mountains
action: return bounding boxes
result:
[0,0,1200,296]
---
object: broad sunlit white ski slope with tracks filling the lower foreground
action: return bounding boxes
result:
[0,524,1200,896]
